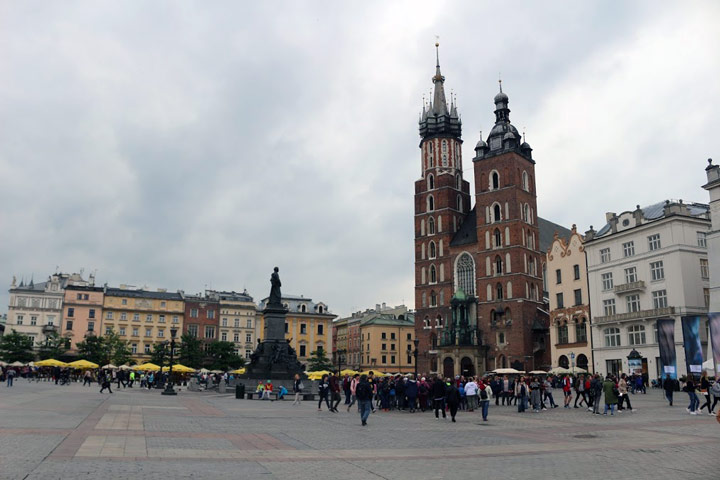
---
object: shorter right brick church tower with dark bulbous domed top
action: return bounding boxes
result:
[470,83,549,371]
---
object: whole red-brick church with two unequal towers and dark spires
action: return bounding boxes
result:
[414,45,567,377]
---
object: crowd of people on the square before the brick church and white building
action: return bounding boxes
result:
[293,372,720,425]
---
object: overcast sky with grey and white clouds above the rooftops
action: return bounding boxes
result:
[0,0,720,315]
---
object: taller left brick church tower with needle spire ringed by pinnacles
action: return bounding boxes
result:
[415,43,470,371]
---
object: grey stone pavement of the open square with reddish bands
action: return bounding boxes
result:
[0,380,720,480]
